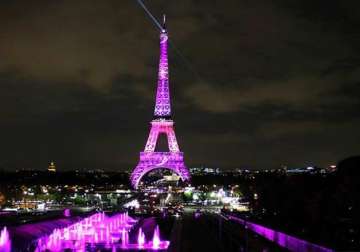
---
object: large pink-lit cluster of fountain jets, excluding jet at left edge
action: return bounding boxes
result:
[34,213,170,252]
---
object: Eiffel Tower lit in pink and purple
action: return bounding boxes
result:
[130,16,190,188]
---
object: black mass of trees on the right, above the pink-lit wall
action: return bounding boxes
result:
[192,157,360,251]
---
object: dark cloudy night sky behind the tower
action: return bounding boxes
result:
[0,0,360,170]
